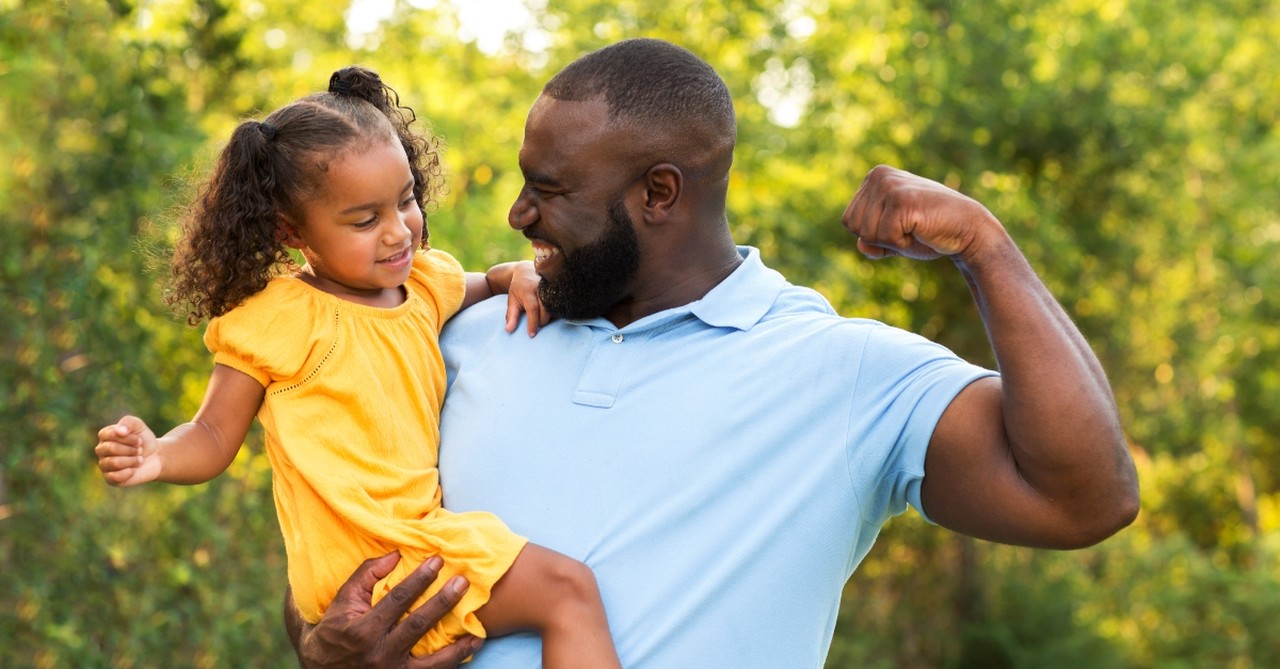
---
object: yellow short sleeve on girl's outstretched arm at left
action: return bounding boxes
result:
[205,279,320,388]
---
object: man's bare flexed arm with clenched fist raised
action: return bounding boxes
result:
[844,166,1138,549]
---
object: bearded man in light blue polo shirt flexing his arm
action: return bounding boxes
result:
[293,40,1138,669]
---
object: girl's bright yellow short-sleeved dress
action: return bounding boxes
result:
[205,249,525,654]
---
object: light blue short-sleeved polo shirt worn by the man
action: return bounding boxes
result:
[440,247,993,669]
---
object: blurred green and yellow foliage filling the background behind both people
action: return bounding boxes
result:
[0,0,1280,668]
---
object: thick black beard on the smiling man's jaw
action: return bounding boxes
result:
[538,200,640,320]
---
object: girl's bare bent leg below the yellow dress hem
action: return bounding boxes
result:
[476,544,622,669]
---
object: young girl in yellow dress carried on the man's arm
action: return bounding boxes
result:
[95,67,618,668]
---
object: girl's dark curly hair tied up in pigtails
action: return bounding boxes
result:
[165,65,444,325]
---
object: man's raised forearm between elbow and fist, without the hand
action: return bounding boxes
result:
[957,237,1138,536]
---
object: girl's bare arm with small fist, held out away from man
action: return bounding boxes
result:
[93,365,264,486]
